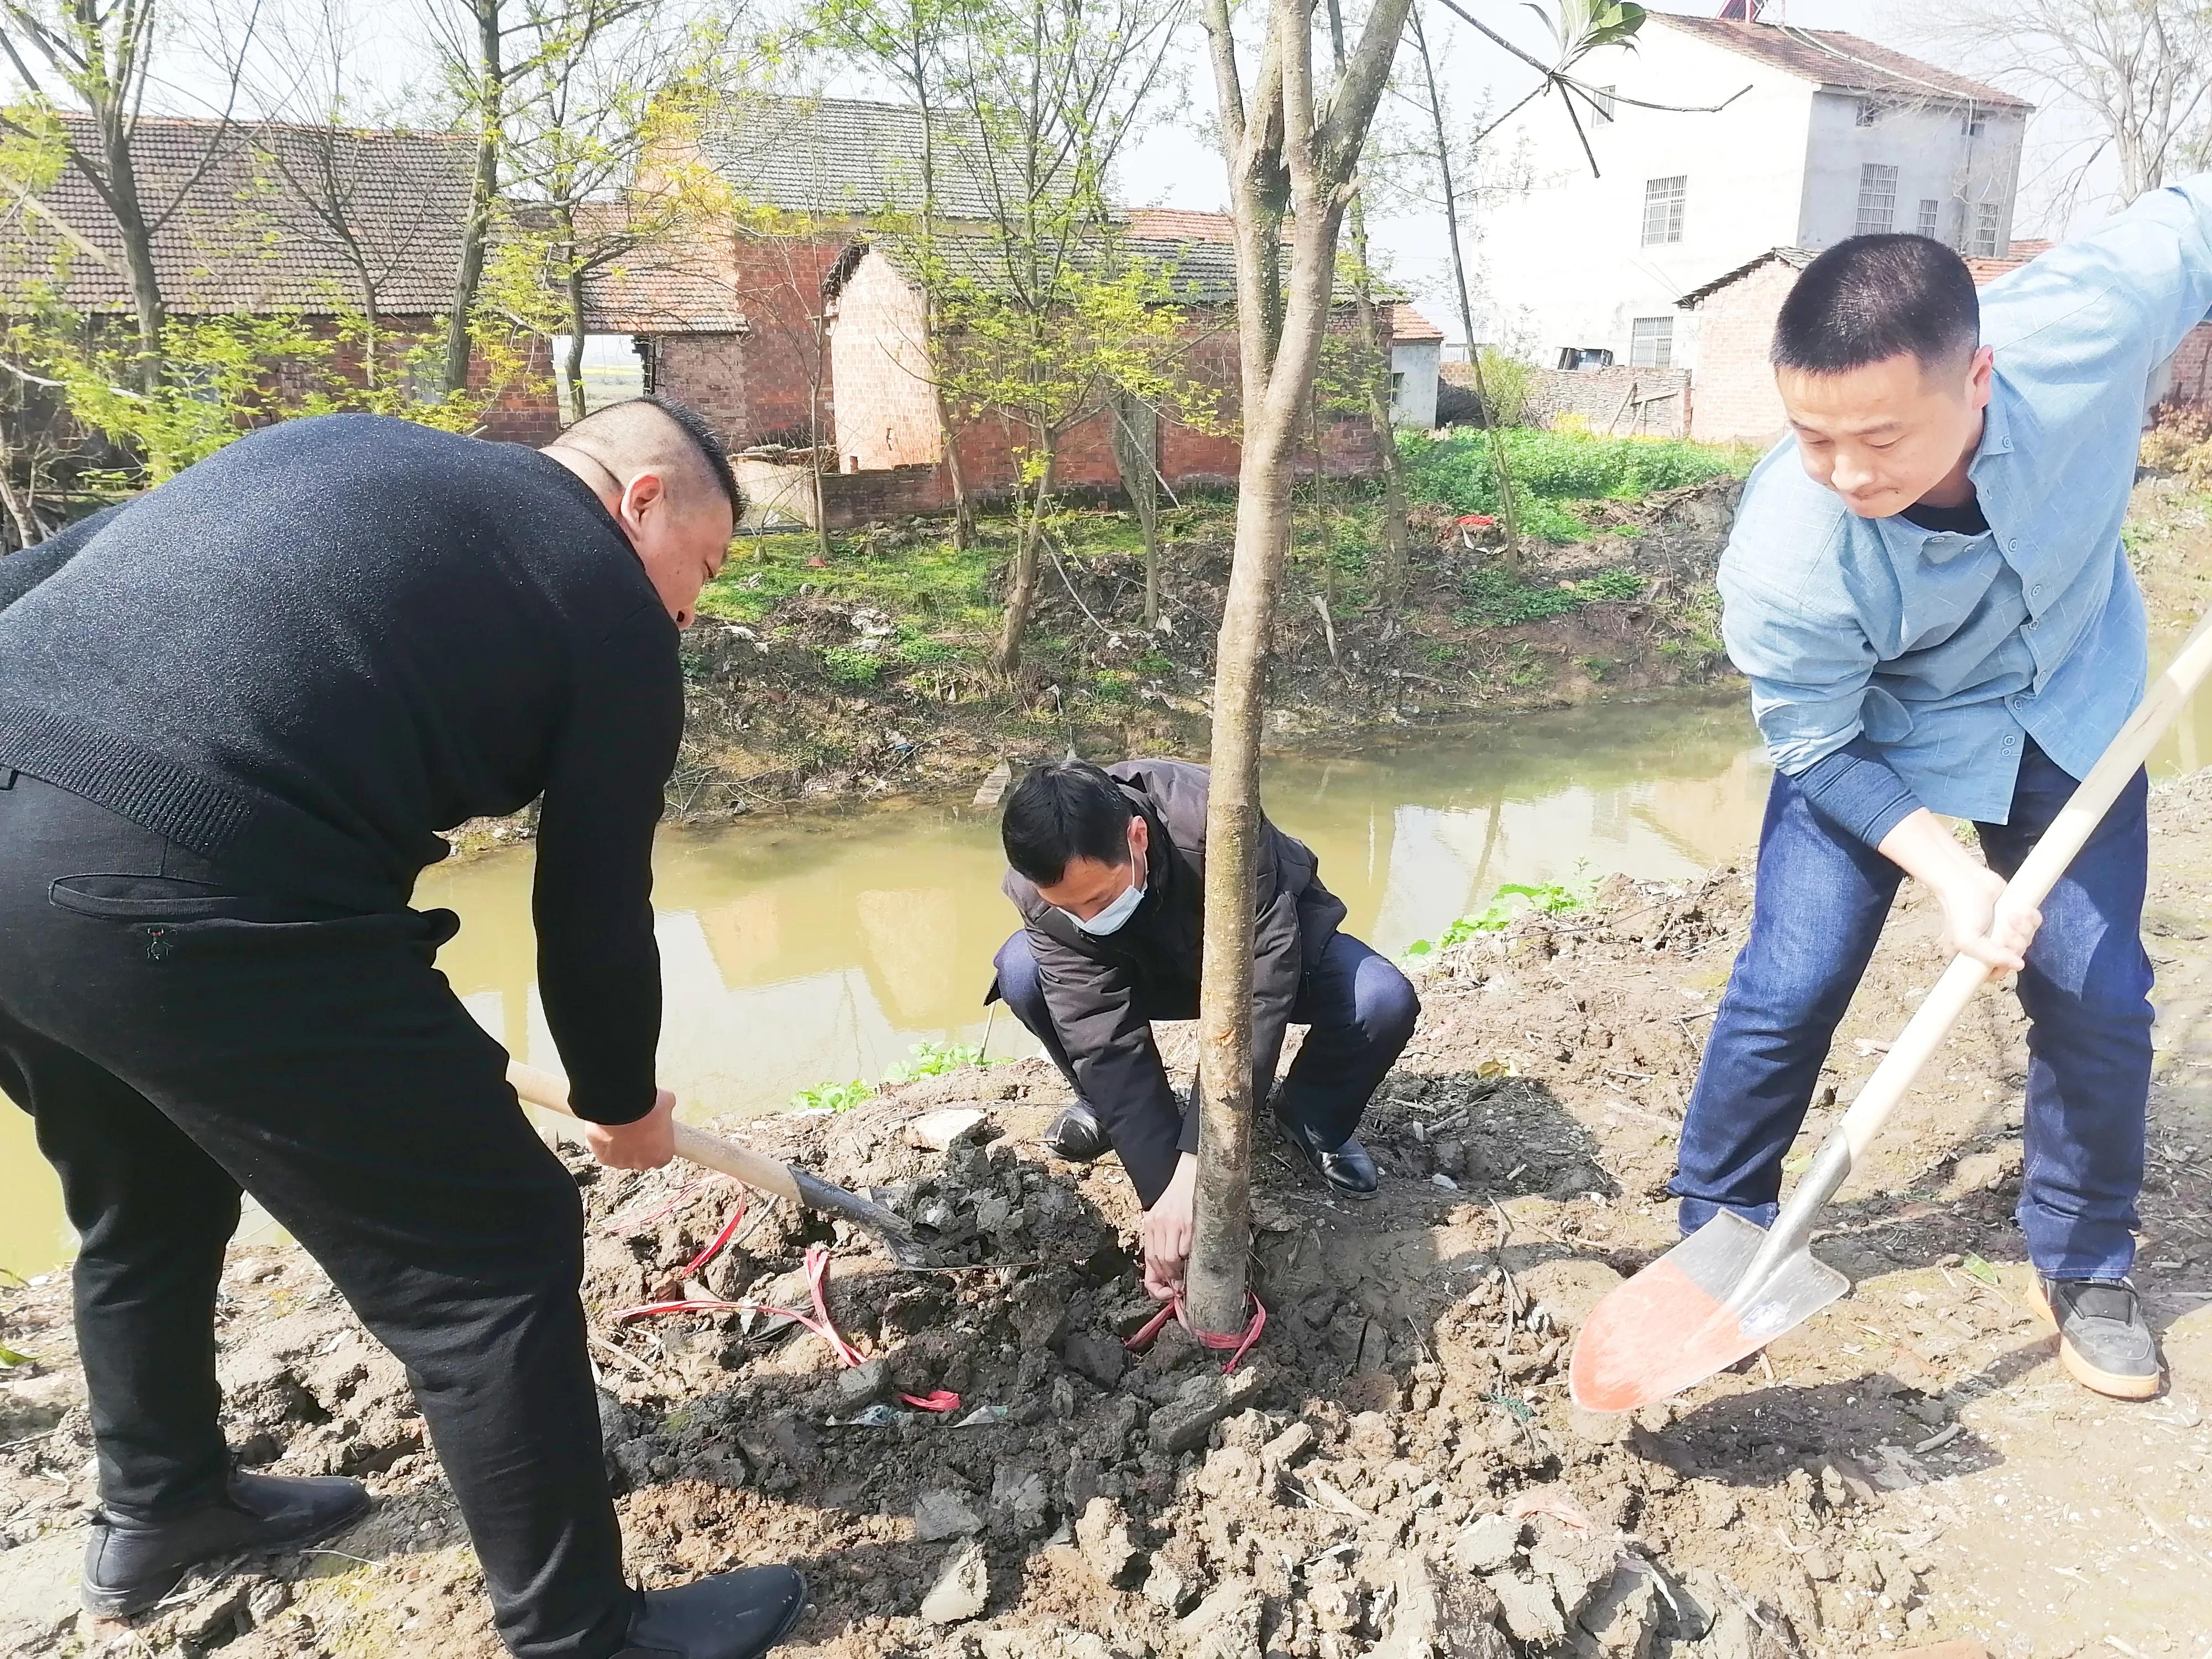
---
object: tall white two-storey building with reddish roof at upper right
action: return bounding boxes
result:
[1484,11,2031,369]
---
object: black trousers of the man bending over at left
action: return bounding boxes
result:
[0,768,635,1659]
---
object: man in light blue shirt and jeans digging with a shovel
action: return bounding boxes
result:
[1672,177,2212,1398]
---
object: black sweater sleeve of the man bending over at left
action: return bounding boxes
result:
[531,604,684,1124]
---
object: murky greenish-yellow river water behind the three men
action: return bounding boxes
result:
[0,688,2212,1274]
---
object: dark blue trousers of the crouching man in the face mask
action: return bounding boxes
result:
[998,931,1420,1146]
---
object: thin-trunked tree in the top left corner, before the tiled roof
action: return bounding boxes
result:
[0,0,254,392]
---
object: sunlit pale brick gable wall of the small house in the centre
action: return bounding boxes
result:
[832,252,942,471]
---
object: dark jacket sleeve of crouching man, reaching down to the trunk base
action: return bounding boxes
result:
[1029,927,1183,1210]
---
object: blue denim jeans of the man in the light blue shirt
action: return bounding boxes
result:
[1670,743,2150,1279]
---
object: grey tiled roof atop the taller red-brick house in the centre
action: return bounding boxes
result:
[699,93,1062,219]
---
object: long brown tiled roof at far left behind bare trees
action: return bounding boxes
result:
[0,115,476,316]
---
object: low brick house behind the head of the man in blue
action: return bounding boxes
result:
[1681,241,2212,445]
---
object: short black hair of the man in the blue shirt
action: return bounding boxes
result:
[1774,237,1982,374]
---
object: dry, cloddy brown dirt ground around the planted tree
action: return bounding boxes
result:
[13,774,2212,1659]
